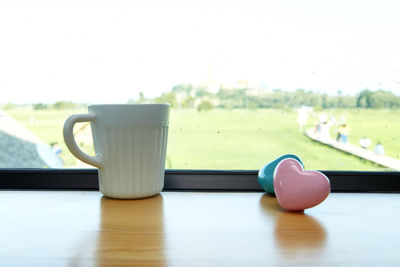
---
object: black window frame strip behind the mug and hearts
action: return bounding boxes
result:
[0,169,400,192]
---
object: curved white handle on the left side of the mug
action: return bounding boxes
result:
[63,113,103,168]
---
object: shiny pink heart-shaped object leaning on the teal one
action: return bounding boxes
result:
[274,158,331,211]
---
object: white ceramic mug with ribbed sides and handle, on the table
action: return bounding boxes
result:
[64,104,170,199]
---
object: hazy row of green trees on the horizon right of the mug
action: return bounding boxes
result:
[148,84,400,111]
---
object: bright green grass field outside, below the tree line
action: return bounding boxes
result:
[7,109,400,171]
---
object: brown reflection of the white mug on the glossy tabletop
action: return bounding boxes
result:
[96,195,165,266]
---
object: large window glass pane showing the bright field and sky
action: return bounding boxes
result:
[0,0,400,171]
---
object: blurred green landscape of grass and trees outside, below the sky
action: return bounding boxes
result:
[2,87,400,171]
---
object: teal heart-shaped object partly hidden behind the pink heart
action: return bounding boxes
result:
[257,154,304,194]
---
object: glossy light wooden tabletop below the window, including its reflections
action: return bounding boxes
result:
[0,191,400,266]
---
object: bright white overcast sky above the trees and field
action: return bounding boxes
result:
[0,0,400,103]
